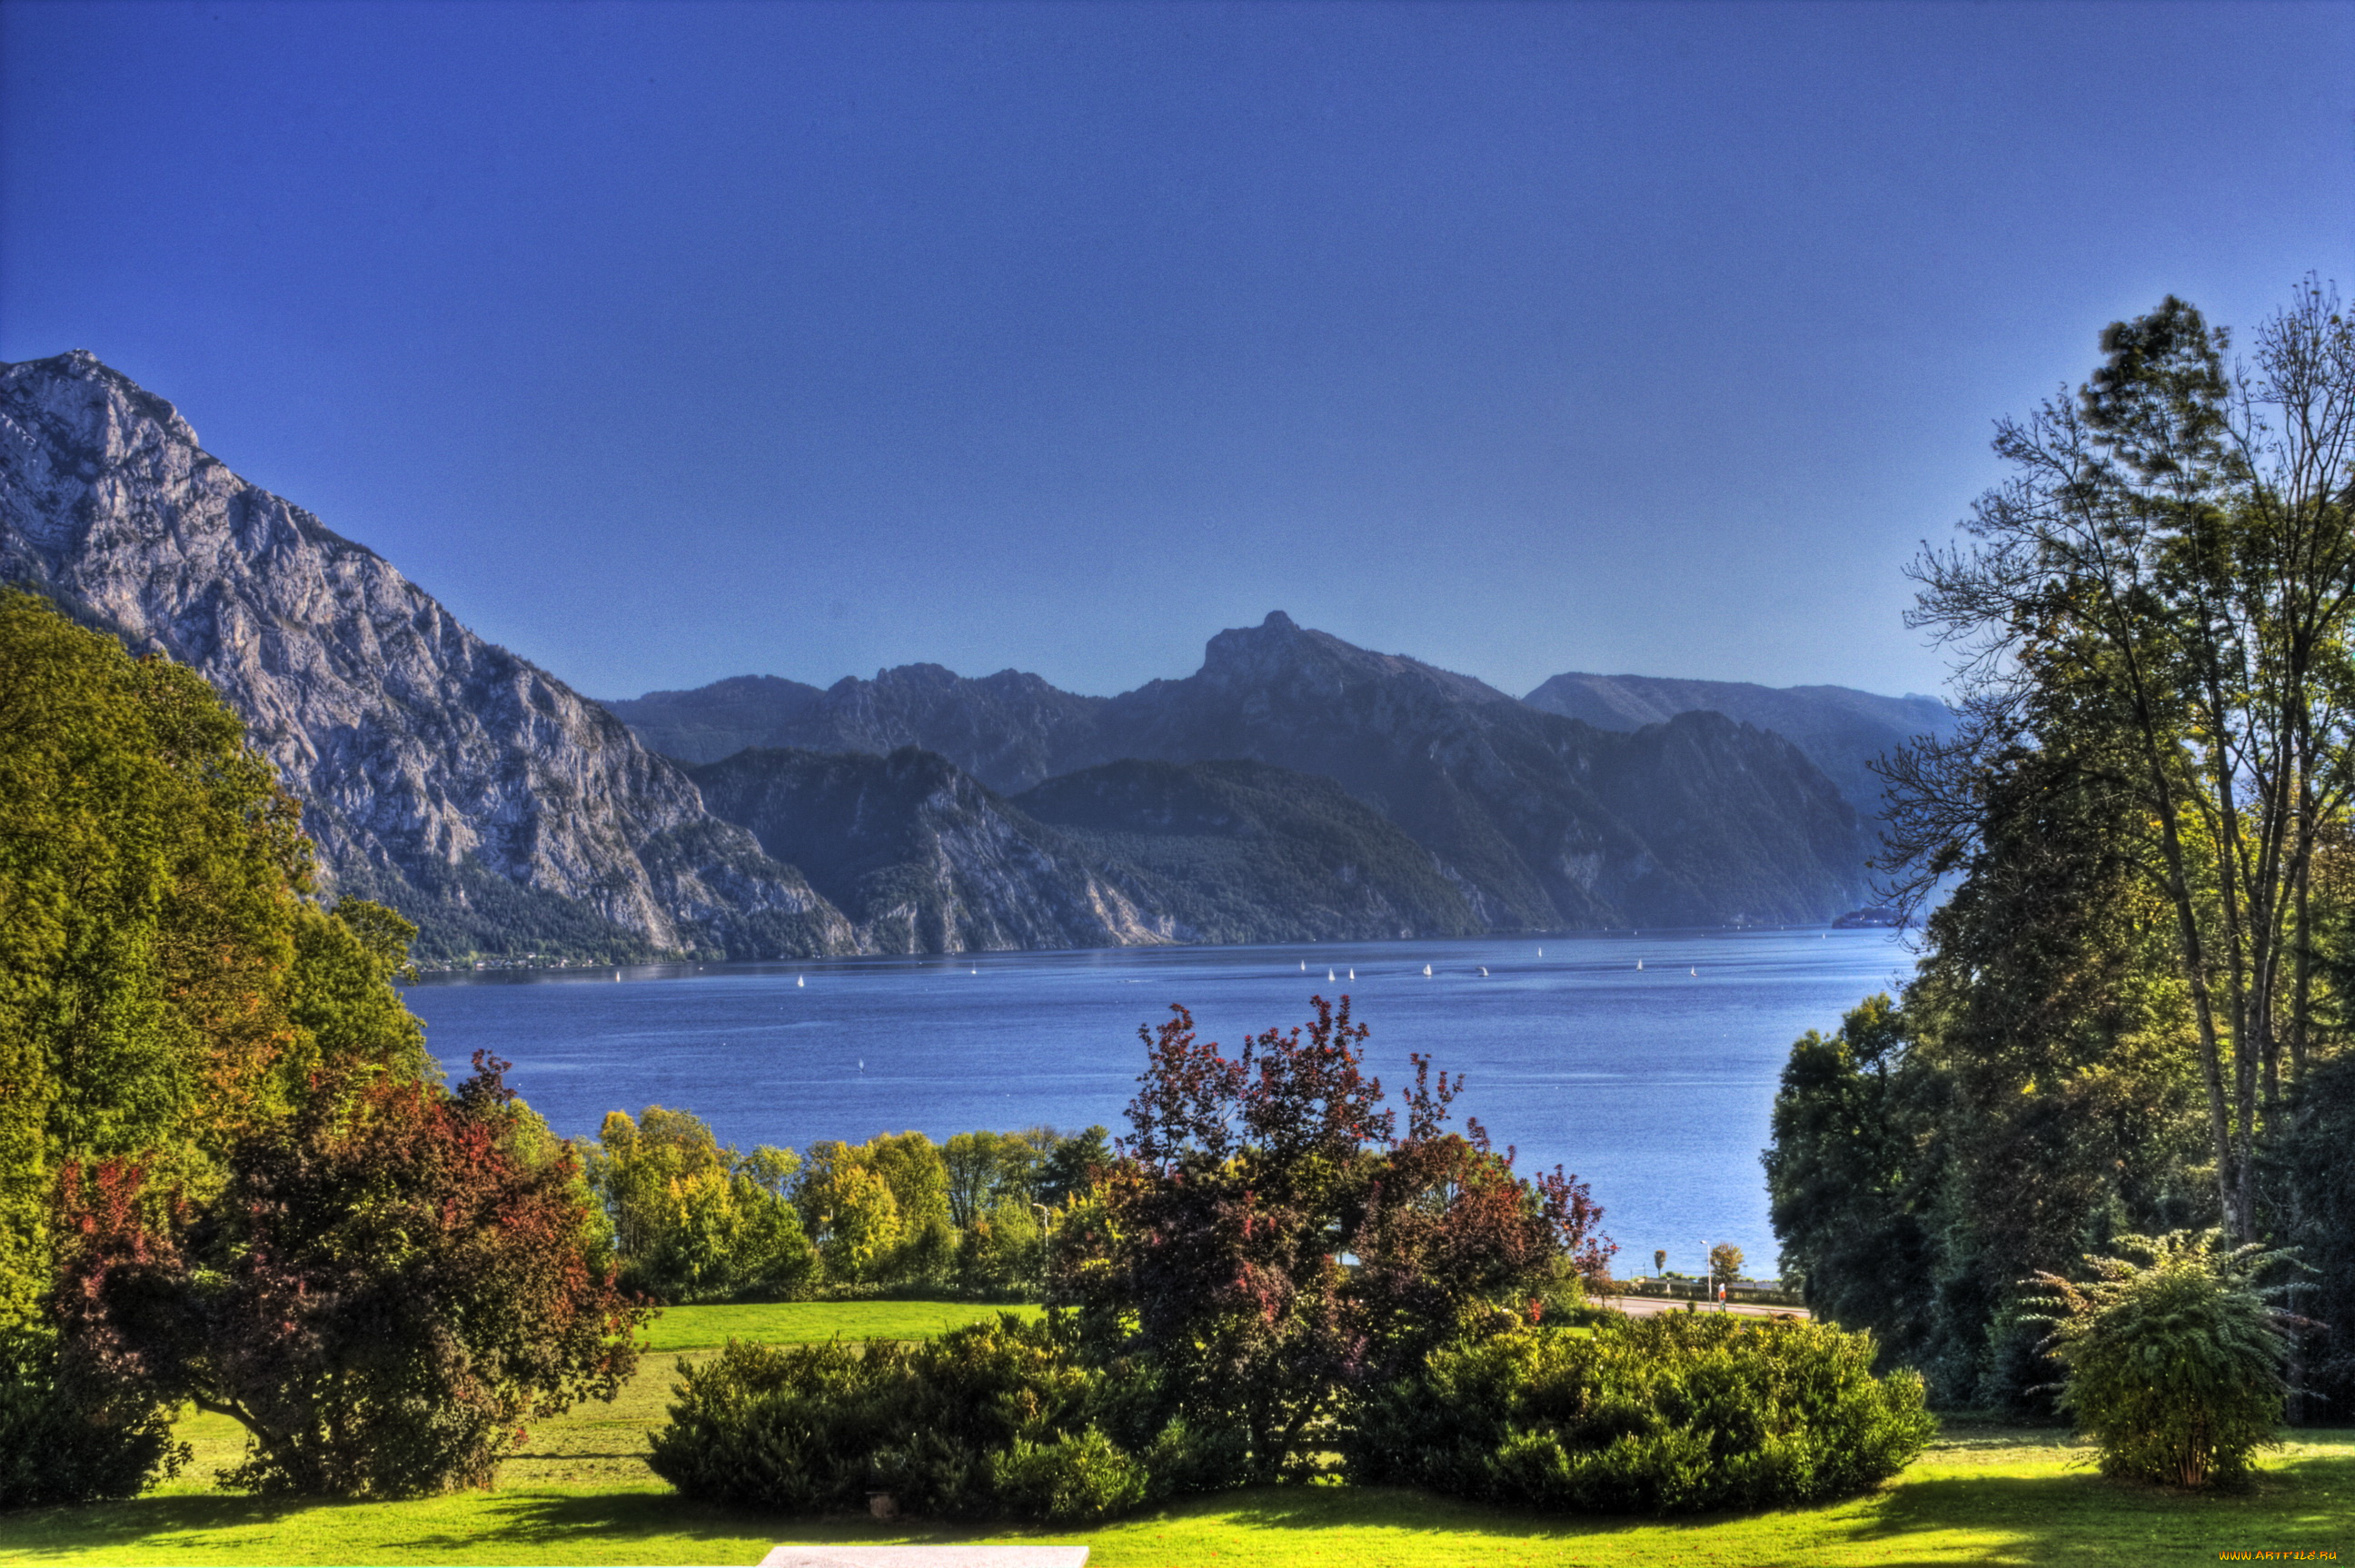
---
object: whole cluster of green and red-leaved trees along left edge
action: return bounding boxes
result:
[0,593,643,1507]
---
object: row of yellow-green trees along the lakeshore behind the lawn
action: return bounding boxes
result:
[589,1107,1111,1305]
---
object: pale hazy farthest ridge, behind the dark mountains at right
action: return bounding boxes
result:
[1521,673,1957,817]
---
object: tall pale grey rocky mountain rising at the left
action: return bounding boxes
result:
[0,353,855,958]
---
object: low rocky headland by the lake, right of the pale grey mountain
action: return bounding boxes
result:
[695,747,1187,954]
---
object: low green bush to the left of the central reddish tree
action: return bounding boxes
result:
[650,1314,1189,1521]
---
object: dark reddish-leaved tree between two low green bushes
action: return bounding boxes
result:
[1050,998,1608,1481]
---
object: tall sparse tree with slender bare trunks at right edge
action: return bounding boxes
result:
[1893,283,2355,1241]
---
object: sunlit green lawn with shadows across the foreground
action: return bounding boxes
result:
[0,1302,2355,1568]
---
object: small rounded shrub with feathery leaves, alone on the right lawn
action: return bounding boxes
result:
[2034,1231,2289,1485]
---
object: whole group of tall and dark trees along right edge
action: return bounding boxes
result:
[1766,283,2355,1410]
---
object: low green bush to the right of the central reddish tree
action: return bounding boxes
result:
[1340,1312,1936,1513]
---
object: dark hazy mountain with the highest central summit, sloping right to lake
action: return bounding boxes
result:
[1098,612,1865,930]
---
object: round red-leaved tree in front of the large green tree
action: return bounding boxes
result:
[59,1052,650,1497]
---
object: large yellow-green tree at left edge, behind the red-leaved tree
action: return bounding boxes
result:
[0,590,429,1507]
